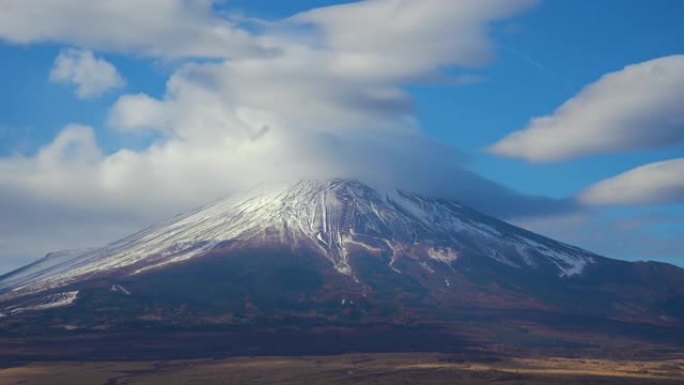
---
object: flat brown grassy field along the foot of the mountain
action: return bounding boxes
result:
[0,354,684,385]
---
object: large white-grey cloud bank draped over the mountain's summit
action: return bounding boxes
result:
[0,48,576,224]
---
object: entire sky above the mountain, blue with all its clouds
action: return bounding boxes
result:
[0,0,684,271]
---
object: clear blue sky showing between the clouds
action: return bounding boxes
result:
[0,0,684,269]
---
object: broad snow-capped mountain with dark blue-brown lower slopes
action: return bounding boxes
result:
[0,179,684,351]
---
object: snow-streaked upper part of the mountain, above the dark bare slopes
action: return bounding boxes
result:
[0,179,596,300]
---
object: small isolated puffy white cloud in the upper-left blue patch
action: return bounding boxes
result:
[50,49,124,99]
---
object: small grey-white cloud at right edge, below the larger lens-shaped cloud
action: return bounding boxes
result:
[580,158,684,205]
